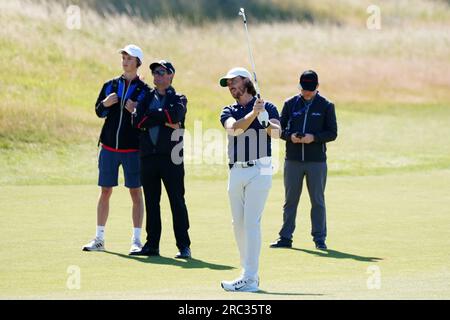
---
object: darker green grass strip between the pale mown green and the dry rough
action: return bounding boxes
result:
[0,104,450,185]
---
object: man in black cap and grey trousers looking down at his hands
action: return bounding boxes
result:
[270,70,337,250]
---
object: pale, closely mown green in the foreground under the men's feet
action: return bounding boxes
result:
[0,170,450,299]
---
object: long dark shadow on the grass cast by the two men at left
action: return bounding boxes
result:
[104,251,235,270]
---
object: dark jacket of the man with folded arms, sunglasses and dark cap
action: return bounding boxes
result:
[132,87,187,157]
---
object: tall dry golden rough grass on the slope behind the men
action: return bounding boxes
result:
[0,0,450,140]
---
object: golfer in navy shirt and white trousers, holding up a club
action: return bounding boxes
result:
[220,68,280,292]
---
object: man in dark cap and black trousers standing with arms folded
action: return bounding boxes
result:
[131,60,191,259]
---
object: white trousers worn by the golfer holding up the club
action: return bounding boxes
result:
[228,158,272,280]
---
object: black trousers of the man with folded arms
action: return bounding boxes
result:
[141,155,191,249]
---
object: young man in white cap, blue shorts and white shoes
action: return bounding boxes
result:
[82,45,149,253]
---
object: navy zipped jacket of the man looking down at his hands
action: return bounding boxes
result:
[280,93,337,162]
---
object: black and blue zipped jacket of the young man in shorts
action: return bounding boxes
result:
[95,76,149,150]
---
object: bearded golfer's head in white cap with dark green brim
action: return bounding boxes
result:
[219,68,256,100]
